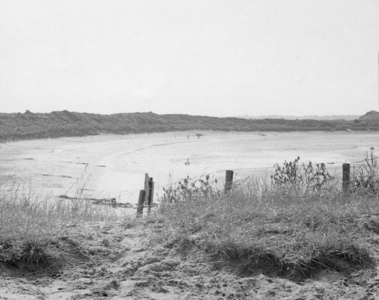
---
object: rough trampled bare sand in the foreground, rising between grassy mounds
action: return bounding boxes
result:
[0,218,379,300]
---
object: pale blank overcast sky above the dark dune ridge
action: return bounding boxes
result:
[0,0,379,117]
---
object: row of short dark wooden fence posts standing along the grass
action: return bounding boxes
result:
[137,163,360,216]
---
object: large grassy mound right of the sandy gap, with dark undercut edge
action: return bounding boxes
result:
[154,171,379,280]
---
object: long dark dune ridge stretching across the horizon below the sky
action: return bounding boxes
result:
[0,110,379,142]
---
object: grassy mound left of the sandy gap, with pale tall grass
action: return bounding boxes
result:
[0,186,120,272]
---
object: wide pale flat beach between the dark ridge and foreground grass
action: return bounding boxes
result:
[0,132,379,203]
